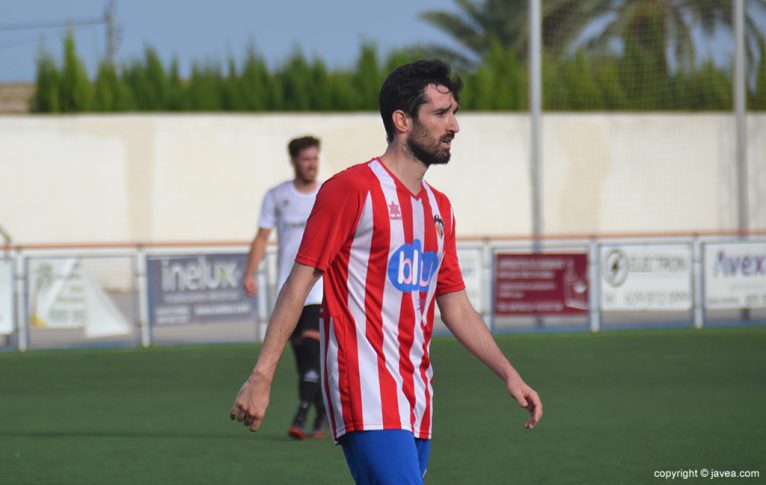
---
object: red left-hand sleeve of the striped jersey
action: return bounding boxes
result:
[295,173,362,272]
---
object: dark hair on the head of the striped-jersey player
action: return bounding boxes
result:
[378,59,463,143]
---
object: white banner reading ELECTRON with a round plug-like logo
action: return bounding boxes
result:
[599,244,692,310]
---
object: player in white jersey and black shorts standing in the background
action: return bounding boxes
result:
[243,136,327,439]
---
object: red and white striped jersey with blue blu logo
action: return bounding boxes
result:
[296,159,465,440]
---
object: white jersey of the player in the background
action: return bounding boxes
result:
[258,180,322,305]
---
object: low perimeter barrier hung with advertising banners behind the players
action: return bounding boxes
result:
[0,232,766,351]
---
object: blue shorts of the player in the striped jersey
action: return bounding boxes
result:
[338,429,431,485]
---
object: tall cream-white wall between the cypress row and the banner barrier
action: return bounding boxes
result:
[0,113,766,243]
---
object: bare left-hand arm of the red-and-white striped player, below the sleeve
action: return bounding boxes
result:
[230,263,322,431]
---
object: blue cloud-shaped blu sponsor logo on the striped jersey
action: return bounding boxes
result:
[388,239,439,292]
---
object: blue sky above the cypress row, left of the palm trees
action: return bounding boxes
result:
[0,0,464,83]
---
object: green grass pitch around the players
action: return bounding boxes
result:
[0,327,766,484]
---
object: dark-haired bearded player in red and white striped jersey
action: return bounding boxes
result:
[230,60,543,484]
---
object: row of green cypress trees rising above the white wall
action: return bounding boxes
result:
[30,30,752,113]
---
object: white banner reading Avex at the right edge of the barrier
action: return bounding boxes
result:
[704,242,766,309]
